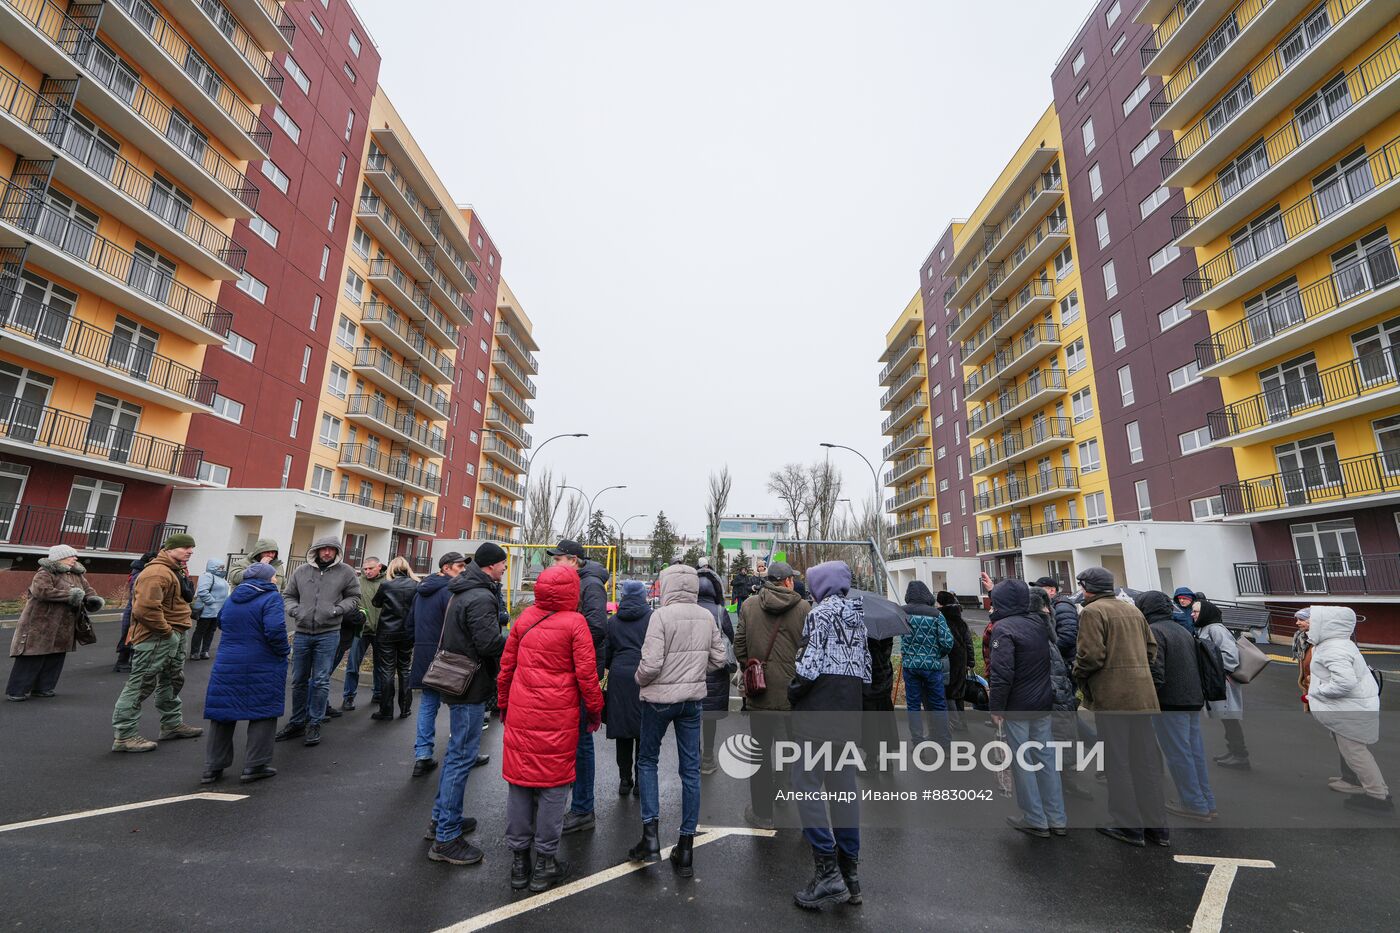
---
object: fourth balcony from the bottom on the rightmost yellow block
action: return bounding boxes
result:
[1196,240,1400,377]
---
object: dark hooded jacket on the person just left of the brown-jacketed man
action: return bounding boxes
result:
[987,579,1054,712]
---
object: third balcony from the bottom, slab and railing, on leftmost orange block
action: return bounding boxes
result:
[0,287,218,412]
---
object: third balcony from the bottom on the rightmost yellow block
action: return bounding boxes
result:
[1205,347,1400,447]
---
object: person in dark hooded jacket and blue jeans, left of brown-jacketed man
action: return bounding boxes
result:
[987,579,1068,838]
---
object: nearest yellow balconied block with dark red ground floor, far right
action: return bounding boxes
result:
[1137,0,1400,642]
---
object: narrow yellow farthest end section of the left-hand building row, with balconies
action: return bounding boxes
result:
[475,274,539,541]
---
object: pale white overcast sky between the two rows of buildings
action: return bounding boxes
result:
[357,0,1092,534]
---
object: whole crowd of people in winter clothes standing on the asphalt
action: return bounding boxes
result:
[6,534,1393,909]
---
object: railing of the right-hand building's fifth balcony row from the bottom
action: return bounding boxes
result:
[1184,139,1400,300]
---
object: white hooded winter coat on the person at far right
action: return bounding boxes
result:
[1308,605,1380,745]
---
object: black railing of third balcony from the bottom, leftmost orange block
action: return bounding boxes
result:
[0,286,218,405]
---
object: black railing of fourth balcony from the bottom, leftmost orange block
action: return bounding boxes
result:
[0,179,234,336]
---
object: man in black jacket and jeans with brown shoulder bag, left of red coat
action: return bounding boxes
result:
[428,542,505,864]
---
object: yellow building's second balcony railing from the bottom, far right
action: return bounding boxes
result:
[1221,451,1400,516]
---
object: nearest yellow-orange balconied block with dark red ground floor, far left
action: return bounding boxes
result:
[0,0,295,572]
